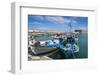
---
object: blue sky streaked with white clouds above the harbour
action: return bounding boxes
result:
[28,15,88,32]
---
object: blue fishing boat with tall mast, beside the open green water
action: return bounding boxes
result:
[59,19,79,58]
